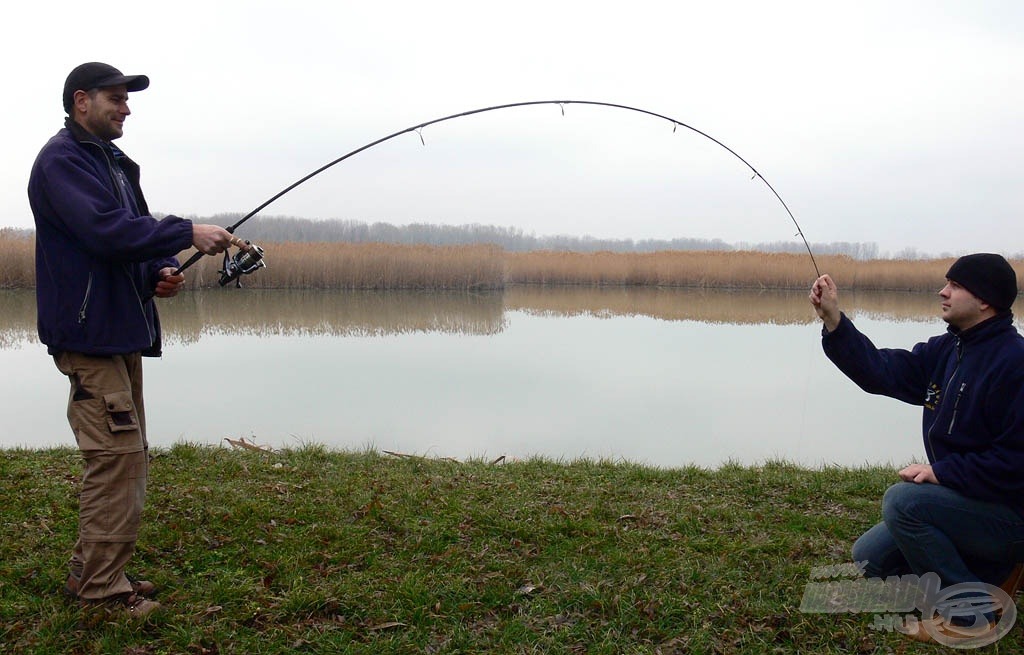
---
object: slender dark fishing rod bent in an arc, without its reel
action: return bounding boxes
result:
[176,100,821,277]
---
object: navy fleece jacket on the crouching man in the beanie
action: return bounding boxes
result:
[821,311,1024,515]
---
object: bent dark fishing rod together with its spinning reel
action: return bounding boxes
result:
[175,100,821,286]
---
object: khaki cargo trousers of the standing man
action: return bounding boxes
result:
[53,352,148,600]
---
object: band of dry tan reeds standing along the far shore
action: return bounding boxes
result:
[0,234,1024,291]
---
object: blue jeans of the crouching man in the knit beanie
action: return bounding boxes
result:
[853,482,1024,587]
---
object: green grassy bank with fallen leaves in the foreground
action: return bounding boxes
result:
[0,445,1024,655]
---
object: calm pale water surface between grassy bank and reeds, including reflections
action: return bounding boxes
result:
[0,290,966,467]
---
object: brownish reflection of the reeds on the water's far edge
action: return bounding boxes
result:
[0,287,939,349]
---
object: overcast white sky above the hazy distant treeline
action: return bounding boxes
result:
[0,0,1024,255]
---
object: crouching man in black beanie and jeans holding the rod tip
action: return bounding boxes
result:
[810,253,1024,645]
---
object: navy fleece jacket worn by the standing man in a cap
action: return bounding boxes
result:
[29,119,193,355]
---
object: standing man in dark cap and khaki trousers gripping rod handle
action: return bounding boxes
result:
[29,61,238,617]
